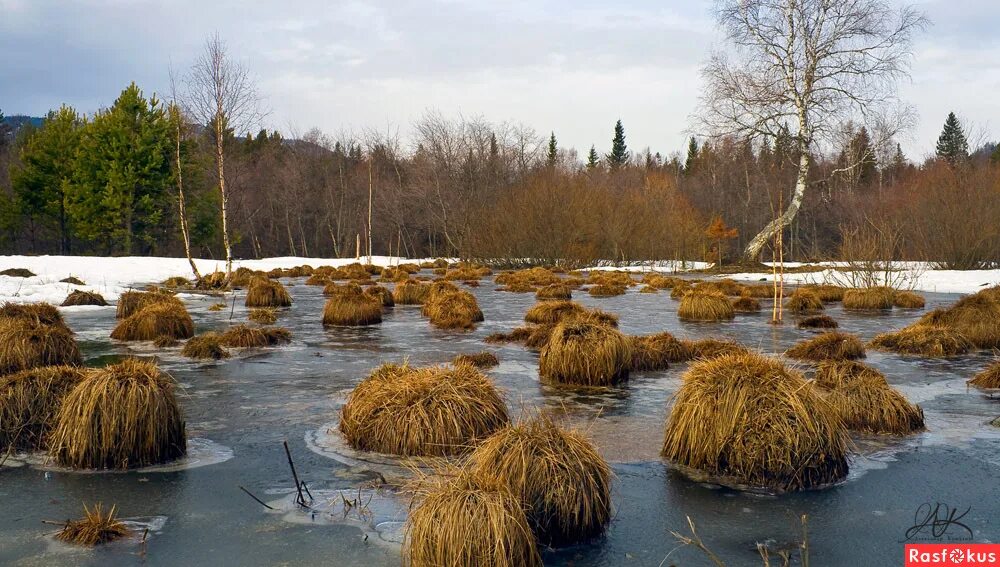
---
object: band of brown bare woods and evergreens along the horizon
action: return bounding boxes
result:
[0,93,1000,269]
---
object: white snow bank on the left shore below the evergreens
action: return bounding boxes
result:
[0,256,442,309]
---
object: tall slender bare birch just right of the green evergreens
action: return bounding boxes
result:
[187,33,263,282]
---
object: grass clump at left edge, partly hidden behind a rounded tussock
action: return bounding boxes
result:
[0,366,84,455]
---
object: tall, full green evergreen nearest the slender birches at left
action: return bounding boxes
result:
[69,83,173,254]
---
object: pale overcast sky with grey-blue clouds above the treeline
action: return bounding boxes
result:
[0,0,1000,158]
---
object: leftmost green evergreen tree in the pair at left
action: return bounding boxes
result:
[10,106,84,253]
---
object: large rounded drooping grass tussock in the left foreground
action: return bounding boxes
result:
[49,358,187,469]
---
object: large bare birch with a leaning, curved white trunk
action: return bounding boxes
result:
[699,0,927,261]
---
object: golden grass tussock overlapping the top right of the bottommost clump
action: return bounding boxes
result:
[468,416,612,545]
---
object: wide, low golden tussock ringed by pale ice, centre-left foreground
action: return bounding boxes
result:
[340,364,510,456]
